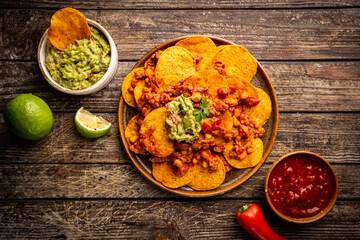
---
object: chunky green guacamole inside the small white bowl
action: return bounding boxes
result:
[45,27,110,90]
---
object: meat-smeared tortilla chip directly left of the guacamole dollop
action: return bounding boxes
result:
[140,107,175,157]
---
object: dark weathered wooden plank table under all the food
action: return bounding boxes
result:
[0,0,360,239]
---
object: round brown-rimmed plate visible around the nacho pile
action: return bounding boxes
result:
[118,36,279,197]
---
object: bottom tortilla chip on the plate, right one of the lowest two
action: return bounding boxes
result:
[188,157,226,190]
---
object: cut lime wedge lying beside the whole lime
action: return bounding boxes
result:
[75,107,111,138]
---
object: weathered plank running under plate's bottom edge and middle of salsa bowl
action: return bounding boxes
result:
[0,164,360,199]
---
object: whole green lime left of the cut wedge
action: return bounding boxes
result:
[4,94,54,140]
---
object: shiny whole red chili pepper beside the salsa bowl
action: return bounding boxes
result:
[236,204,287,240]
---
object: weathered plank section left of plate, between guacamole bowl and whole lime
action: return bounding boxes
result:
[0,61,135,112]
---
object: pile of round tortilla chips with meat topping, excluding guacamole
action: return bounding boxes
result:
[122,36,272,191]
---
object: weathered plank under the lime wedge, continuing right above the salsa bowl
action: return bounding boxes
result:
[0,113,360,163]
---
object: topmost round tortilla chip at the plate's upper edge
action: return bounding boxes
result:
[175,36,217,71]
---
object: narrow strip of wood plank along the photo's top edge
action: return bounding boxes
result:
[3,0,359,9]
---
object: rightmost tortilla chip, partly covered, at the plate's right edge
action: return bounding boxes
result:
[250,88,272,126]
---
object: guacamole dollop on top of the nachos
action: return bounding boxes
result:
[165,95,203,143]
